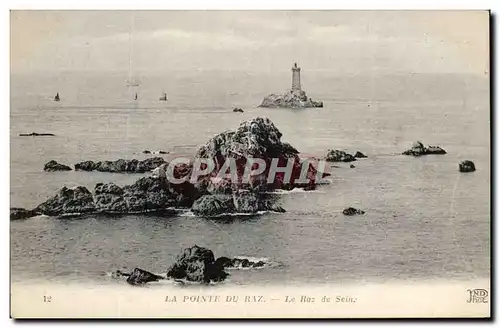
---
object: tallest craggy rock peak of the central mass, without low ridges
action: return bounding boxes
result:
[192,117,329,191]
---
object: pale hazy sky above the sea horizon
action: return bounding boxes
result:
[10,10,489,75]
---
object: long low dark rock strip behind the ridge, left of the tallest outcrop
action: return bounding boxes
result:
[75,157,167,173]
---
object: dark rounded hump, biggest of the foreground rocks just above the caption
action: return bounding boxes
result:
[167,245,229,283]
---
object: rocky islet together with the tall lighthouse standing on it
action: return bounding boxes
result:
[259,63,323,108]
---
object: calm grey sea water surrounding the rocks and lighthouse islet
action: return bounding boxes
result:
[10,71,490,285]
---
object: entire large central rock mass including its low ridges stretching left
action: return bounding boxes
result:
[16,118,329,219]
